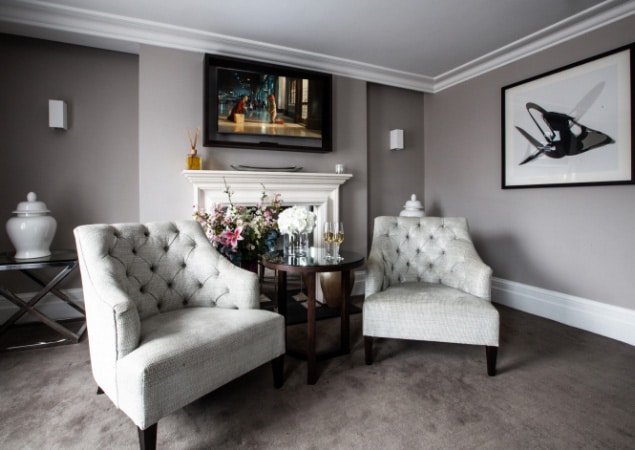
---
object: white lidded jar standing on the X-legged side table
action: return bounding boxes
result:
[7,192,57,259]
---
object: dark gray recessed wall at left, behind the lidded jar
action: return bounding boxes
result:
[0,34,139,289]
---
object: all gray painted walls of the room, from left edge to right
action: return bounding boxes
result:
[0,12,635,316]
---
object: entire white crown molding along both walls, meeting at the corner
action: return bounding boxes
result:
[0,0,635,93]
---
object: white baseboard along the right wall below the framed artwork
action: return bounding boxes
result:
[492,278,635,345]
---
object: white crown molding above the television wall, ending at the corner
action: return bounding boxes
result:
[0,0,433,92]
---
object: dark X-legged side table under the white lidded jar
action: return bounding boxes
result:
[0,250,86,348]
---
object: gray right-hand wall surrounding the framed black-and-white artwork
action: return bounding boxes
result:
[424,17,635,309]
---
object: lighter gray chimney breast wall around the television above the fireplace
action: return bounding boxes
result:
[139,46,368,254]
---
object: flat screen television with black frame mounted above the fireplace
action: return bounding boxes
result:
[203,54,332,153]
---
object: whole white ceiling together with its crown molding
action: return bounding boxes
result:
[0,0,635,92]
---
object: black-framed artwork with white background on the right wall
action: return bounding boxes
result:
[502,44,635,189]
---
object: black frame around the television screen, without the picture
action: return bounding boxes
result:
[203,54,333,153]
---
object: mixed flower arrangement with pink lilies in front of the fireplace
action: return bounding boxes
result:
[194,183,282,266]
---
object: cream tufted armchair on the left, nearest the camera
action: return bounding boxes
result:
[75,221,285,448]
